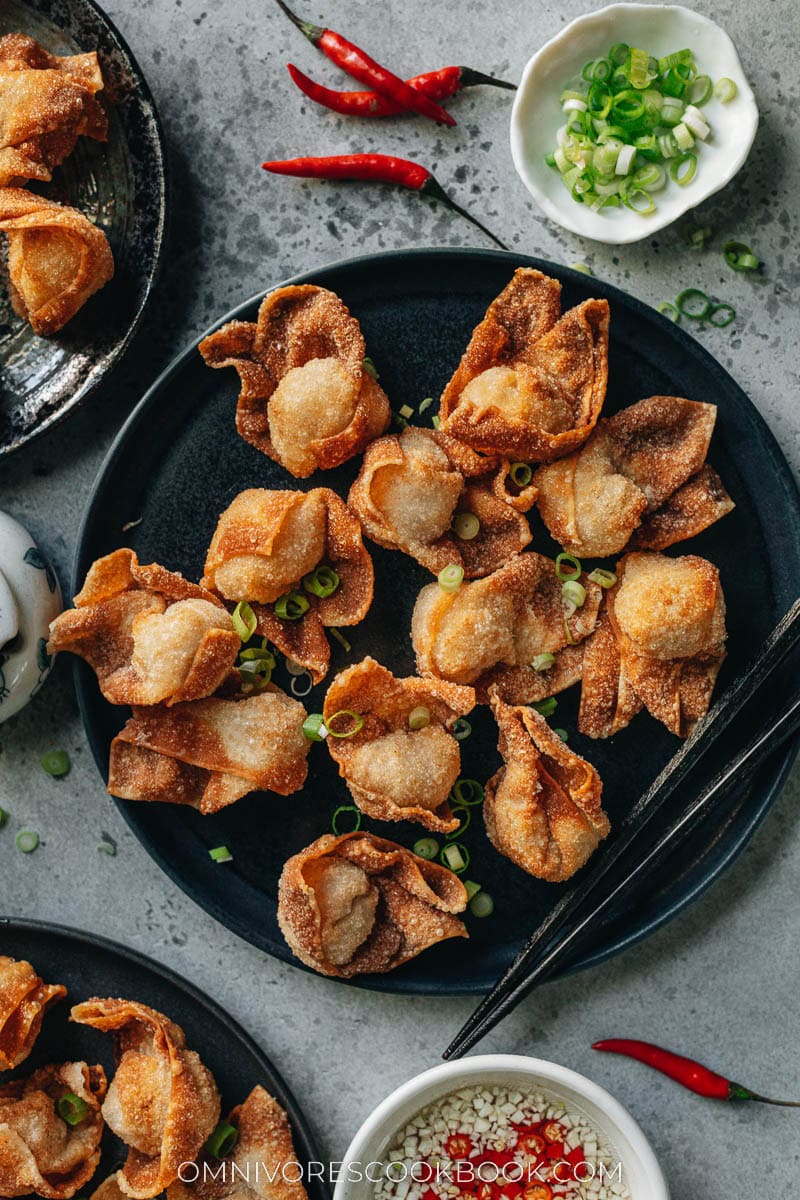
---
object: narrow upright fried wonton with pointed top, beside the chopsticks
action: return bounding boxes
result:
[483,696,610,883]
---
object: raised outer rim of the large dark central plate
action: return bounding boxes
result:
[71,246,800,996]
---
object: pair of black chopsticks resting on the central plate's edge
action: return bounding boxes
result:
[443,600,800,1058]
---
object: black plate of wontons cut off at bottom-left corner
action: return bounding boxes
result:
[0,918,330,1200]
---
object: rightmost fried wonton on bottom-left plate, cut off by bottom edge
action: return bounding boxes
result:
[165,1086,307,1200]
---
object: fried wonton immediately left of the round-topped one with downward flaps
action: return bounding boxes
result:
[411,552,602,704]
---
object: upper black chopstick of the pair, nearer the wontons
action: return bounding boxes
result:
[443,600,800,1058]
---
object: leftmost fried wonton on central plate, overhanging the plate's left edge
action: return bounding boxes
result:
[47,550,241,704]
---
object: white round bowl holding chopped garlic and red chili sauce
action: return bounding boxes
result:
[333,1054,669,1200]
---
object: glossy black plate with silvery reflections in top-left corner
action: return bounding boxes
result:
[0,0,167,455]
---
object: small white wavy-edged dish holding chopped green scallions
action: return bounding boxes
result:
[511,4,758,245]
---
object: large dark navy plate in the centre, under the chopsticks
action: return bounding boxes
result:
[76,250,800,992]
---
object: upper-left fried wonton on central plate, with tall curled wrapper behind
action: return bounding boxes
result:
[199,283,391,479]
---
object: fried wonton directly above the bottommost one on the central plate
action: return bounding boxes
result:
[323,658,475,833]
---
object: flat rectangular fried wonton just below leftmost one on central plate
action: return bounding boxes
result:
[108,689,308,814]
